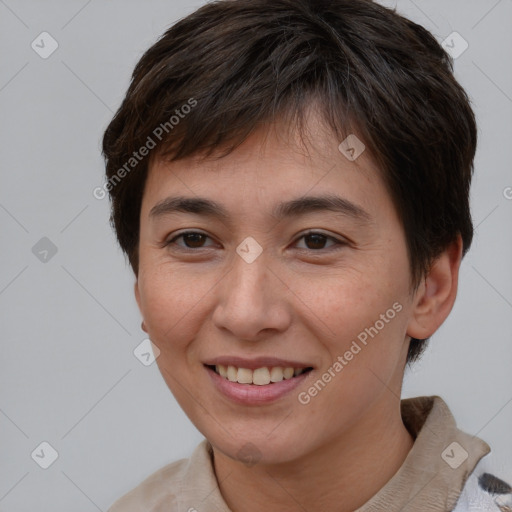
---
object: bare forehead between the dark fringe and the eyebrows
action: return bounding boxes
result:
[142,117,390,223]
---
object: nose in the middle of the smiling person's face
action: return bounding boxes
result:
[213,253,292,341]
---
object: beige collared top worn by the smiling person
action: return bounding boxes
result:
[108,396,512,512]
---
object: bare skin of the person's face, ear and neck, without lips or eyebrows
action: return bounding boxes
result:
[135,116,462,512]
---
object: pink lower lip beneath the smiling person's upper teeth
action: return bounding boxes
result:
[205,366,313,405]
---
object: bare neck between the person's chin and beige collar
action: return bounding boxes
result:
[214,400,414,512]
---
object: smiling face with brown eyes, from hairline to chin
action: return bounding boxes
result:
[135,118,412,463]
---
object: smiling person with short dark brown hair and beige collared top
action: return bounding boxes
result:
[103,0,510,512]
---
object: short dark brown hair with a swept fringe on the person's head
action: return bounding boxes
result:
[103,0,477,362]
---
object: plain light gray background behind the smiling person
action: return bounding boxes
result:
[0,0,512,512]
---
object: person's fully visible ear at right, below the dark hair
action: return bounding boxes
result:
[407,235,462,340]
